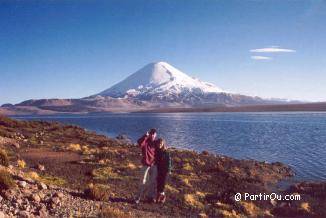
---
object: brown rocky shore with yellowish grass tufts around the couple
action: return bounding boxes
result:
[0,116,326,218]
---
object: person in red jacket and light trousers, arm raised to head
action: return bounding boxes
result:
[135,129,158,204]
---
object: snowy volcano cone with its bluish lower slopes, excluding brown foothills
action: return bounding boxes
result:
[95,62,272,107]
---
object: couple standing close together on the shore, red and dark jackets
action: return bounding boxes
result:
[135,129,171,204]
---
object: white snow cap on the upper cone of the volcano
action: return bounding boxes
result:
[98,62,223,97]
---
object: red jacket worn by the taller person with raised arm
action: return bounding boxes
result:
[137,135,157,166]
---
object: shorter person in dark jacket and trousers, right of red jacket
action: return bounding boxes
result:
[156,138,172,203]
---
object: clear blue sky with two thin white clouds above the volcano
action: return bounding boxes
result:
[0,0,326,104]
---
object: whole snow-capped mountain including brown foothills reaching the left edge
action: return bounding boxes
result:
[0,62,306,114]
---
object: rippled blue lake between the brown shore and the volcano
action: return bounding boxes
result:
[15,112,326,181]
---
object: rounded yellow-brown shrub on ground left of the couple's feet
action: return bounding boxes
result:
[84,183,110,201]
